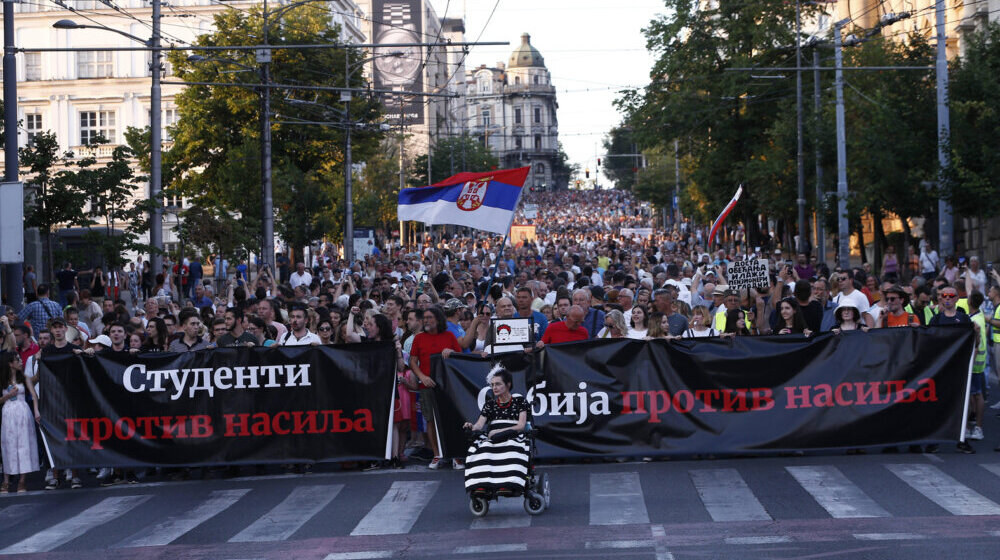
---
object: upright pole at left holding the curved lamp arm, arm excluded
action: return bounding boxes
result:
[149,0,162,288]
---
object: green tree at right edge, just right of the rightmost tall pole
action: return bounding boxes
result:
[942,22,1000,218]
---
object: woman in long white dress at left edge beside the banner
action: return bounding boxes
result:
[0,352,41,493]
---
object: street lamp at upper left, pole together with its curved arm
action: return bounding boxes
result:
[52,4,163,286]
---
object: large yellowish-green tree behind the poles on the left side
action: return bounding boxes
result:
[164,5,380,253]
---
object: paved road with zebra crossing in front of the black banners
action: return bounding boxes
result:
[0,442,1000,560]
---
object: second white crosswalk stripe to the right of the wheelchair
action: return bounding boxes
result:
[688,469,771,521]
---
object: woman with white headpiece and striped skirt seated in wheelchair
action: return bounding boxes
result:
[463,366,531,498]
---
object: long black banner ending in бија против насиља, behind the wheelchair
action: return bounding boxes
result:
[434,326,974,457]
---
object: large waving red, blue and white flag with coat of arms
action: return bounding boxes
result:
[396,167,531,235]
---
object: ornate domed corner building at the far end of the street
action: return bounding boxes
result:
[466,33,565,189]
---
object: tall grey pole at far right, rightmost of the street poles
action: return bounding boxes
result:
[934,0,955,257]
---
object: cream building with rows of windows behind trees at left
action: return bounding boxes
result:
[0,0,366,278]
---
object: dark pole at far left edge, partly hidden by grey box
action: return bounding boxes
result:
[0,0,24,311]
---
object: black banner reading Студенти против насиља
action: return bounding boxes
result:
[39,343,396,467]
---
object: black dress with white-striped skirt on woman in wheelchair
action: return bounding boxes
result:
[465,395,530,492]
